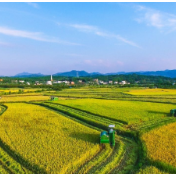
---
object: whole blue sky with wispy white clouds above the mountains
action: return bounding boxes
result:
[0,2,176,76]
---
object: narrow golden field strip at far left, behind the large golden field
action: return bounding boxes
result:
[0,95,50,103]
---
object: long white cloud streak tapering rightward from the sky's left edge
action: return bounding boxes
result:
[0,26,79,45]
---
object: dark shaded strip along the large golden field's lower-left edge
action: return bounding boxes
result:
[0,139,46,174]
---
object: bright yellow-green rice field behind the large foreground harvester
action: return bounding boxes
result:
[54,99,175,124]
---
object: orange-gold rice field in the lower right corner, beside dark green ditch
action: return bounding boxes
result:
[142,123,176,167]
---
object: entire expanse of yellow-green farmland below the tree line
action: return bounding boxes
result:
[0,86,176,174]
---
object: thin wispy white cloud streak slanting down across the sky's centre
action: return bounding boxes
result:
[69,24,141,48]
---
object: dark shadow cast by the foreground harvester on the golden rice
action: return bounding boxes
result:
[70,131,100,144]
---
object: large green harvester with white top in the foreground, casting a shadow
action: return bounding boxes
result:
[100,125,116,147]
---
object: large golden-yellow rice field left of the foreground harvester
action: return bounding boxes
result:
[0,103,100,174]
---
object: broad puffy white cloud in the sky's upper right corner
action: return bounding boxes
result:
[135,6,176,31]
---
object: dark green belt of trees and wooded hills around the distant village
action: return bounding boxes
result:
[0,74,176,90]
